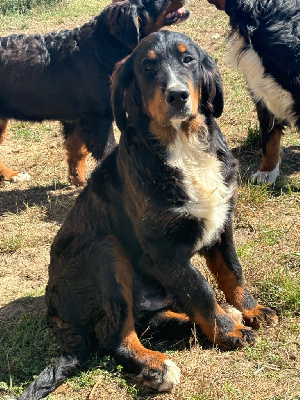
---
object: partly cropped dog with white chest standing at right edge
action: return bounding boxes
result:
[208,0,300,183]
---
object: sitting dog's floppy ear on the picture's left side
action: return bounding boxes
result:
[111,54,142,131]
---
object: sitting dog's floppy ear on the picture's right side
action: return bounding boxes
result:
[200,54,224,118]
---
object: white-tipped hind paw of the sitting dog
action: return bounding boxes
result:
[138,360,180,392]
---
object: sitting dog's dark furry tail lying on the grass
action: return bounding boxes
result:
[18,355,80,400]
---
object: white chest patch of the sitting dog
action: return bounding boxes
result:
[168,132,235,251]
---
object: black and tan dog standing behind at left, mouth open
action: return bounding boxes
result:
[0,0,189,186]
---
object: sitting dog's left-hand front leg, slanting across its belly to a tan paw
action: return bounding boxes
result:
[139,253,256,349]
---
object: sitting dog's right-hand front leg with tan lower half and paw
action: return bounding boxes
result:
[204,219,278,328]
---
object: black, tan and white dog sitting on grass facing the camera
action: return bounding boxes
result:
[20,31,277,400]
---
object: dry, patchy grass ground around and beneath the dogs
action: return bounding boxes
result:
[0,0,300,400]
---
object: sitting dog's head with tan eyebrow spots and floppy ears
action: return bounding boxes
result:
[112,31,223,135]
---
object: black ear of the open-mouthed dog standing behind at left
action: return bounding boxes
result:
[101,0,140,50]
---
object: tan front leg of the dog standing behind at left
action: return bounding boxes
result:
[63,123,89,186]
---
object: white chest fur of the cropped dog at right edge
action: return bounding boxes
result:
[228,34,296,124]
